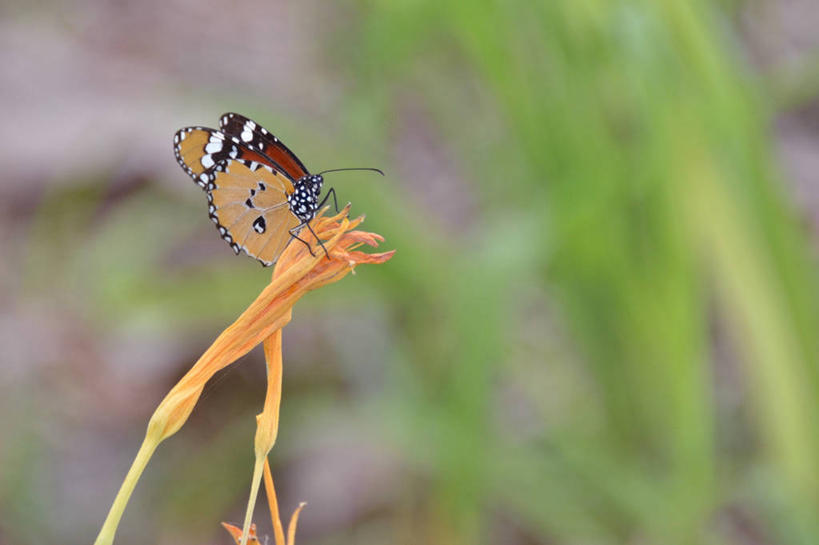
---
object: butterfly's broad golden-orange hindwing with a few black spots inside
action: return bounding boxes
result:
[208,158,301,267]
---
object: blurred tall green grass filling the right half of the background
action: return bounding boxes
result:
[342,1,819,543]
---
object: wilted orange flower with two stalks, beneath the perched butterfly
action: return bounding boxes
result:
[95,205,394,545]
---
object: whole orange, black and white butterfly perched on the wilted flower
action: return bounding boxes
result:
[173,113,384,267]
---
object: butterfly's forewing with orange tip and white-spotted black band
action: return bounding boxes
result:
[173,127,276,191]
